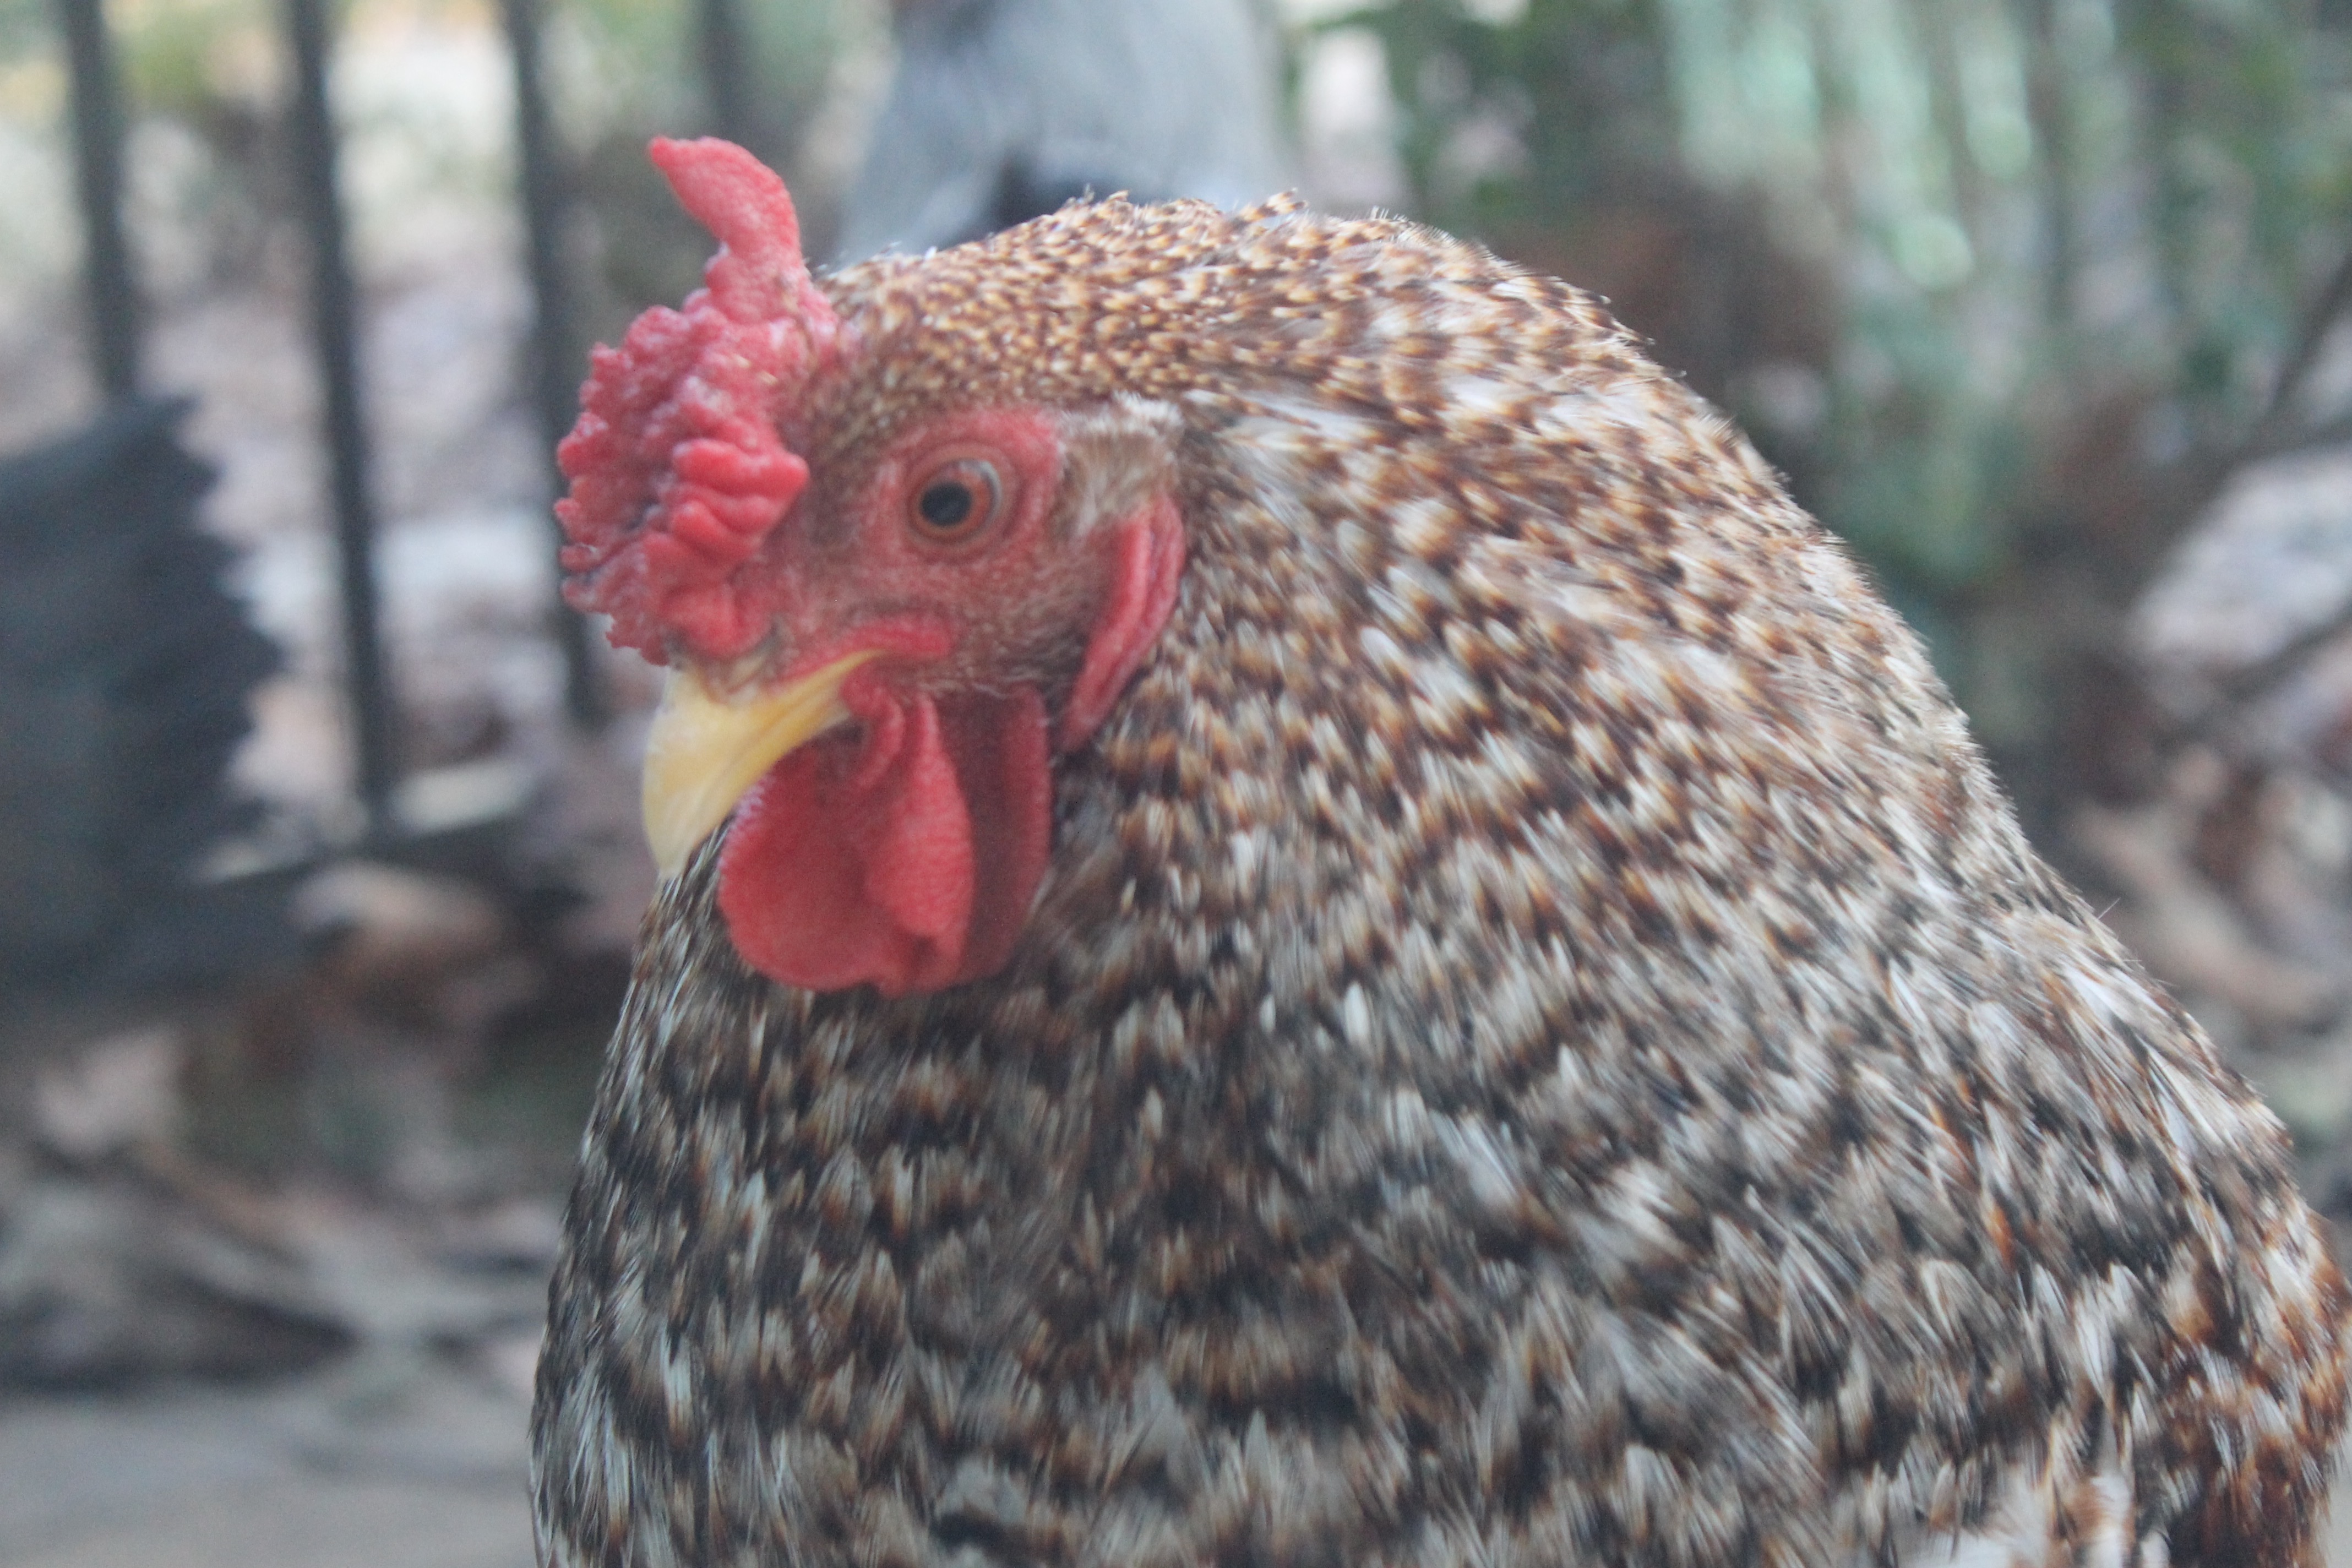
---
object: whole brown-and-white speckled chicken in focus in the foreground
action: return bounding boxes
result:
[534,141,2347,1568]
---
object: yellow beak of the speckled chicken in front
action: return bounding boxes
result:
[645,649,880,877]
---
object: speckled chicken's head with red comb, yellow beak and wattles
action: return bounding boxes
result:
[557,139,1183,994]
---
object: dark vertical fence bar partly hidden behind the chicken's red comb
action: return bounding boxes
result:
[499,0,605,729]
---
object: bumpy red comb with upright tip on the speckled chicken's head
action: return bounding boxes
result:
[555,137,835,663]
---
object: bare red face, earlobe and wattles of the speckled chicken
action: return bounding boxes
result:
[720,409,1183,994]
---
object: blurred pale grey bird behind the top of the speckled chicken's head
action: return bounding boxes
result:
[840,0,1296,261]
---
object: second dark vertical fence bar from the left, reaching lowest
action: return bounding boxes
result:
[287,0,393,835]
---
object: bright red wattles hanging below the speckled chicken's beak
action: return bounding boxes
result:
[720,689,1054,997]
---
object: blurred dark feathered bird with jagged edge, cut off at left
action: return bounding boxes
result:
[0,400,285,990]
